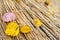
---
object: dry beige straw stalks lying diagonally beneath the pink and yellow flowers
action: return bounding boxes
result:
[0,0,60,40]
